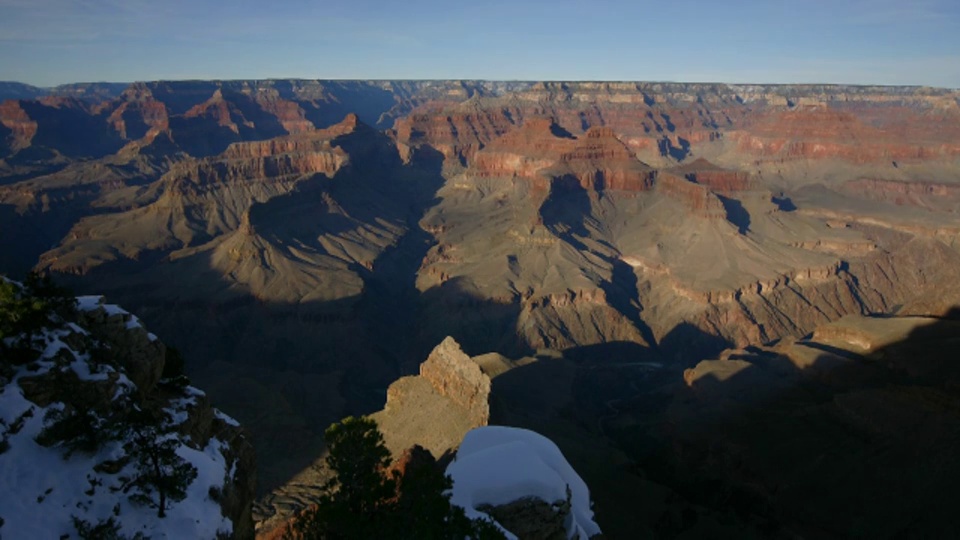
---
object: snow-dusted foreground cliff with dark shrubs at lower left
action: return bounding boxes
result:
[0,279,255,538]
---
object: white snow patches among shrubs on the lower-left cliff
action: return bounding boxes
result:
[0,306,236,540]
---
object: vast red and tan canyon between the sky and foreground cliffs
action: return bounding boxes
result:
[0,80,960,537]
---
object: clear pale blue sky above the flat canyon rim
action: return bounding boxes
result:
[0,0,960,88]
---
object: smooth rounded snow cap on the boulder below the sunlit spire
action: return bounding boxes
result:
[447,426,600,539]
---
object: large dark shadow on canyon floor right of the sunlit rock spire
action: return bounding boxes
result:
[480,310,960,538]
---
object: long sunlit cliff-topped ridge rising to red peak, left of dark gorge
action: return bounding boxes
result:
[34,115,358,274]
